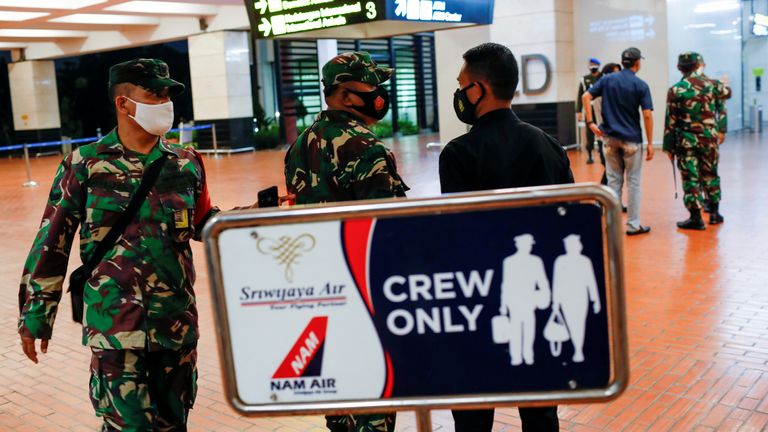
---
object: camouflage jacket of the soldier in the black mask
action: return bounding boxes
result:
[285,111,408,204]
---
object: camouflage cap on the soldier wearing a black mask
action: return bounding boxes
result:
[323,51,394,87]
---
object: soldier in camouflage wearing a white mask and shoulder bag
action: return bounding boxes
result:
[18,59,217,431]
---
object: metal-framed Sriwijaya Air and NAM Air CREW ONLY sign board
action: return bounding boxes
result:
[204,186,628,415]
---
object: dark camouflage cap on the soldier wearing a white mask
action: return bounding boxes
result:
[109,59,184,96]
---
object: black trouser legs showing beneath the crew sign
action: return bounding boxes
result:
[453,406,560,432]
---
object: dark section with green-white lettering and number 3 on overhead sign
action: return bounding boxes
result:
[252,0,385,38]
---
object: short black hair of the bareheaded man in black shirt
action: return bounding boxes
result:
[464,42,520,99]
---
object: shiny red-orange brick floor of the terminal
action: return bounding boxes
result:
[0,135,768,432]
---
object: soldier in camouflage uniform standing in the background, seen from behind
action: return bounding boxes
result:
[664,52,728,230]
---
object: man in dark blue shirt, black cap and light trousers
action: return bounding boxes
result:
[582,47,654,235]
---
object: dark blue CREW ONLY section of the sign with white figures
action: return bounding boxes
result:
[348,205,610,397]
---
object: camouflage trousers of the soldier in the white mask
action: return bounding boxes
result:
[90,344,197,432]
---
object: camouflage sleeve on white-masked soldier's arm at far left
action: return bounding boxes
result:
[18,152,84,339]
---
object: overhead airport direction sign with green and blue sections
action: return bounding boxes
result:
[245,0,493,38]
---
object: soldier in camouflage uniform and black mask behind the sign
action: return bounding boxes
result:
[285,52,408,432]
